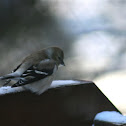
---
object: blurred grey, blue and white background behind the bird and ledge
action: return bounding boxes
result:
[0,0,126,114]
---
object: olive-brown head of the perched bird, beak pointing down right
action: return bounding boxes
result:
[47,47,65,66]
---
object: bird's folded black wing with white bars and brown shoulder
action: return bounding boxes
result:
[12,59,57,87]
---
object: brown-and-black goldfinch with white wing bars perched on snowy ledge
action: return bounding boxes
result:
[0,47,65,94]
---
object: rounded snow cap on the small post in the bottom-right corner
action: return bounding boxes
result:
[94,111,126,125]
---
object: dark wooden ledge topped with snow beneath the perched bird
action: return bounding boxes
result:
[0,80,118,126]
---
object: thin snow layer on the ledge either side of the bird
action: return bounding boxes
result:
[0,80,90,95]
